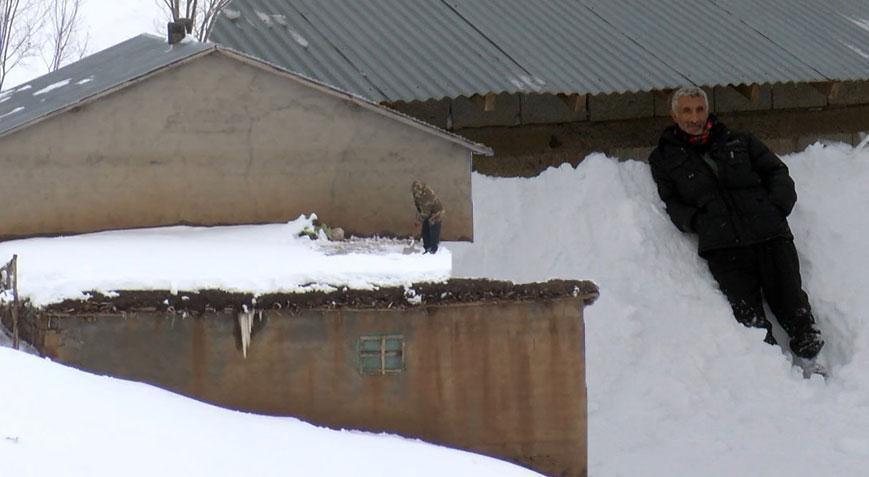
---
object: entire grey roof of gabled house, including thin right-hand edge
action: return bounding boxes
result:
[0,34,493,156]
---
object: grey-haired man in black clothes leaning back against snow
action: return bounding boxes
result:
[649,87,824,360]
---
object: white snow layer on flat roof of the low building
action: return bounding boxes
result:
[0,216,452,305]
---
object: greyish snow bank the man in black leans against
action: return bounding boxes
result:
[449,144,869,477]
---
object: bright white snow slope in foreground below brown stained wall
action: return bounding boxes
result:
[0,348,538,477]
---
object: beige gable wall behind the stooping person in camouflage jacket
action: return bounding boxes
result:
[0,52,473,240]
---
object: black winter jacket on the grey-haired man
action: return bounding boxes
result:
[649,117,797,255]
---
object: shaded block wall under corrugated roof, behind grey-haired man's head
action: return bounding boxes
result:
[393,81,869,176]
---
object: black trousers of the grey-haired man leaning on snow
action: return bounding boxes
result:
[703,239,823,358]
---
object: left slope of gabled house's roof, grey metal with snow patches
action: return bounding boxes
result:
[0,35,209,135]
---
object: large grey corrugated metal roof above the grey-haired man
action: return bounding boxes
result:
[211,0,869,102]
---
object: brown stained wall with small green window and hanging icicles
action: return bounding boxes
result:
[18,297,587,476]
